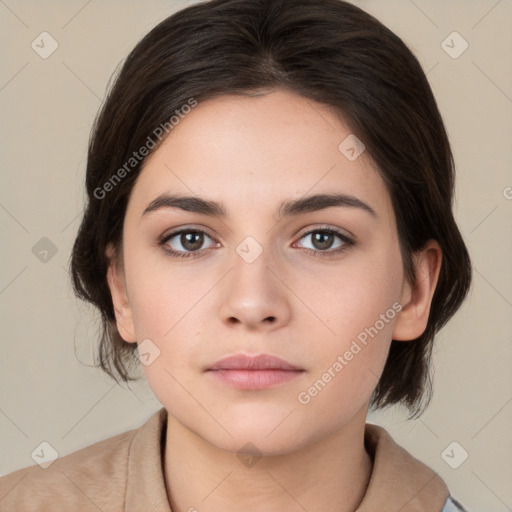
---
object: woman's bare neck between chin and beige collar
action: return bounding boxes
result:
[164,409,372,512]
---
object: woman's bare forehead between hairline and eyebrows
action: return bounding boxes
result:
[130,90,389,220]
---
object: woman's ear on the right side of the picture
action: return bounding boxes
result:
[392,240,443,341]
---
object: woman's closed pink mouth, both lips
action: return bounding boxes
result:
[206,354,305,390]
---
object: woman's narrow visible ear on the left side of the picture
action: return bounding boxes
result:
[106,244,137,343]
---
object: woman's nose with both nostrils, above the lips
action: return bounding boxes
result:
[220,243,291,331]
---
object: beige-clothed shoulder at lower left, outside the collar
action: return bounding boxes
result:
[0,429,137,512]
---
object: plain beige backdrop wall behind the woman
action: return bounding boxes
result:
[0,0,512,512]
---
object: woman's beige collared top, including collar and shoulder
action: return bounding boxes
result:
[0,408,449,512]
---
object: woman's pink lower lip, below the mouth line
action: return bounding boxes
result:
[209,370,303,389]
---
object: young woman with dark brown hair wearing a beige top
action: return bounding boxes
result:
[0,0,471,512]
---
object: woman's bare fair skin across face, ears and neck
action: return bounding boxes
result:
[107,89,442,512]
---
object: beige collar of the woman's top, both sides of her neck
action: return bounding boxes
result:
[125,407,449,512]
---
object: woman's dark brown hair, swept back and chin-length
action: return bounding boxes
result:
[70,0,471,415]
